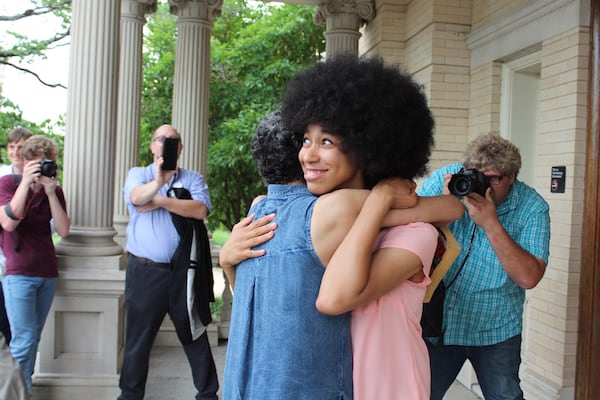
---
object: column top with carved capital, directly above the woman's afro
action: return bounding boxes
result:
[314,0,375,59]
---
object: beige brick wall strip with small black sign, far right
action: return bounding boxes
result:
[524,25,589,387]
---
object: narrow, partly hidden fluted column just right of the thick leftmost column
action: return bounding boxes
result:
[113,0,156,247]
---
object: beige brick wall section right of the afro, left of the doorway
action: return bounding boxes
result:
[382,0,471,170]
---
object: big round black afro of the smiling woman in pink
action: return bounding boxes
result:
[281,55,434,188]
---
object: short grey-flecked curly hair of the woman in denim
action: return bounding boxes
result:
[252,109,304,184]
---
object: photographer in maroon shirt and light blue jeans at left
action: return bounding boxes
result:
[0,135,71,392]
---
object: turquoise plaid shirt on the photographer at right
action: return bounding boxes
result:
[417,164,550,346]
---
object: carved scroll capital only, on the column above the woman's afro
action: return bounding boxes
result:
[313,0,375,30]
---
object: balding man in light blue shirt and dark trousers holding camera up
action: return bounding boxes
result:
[118,125,219,400]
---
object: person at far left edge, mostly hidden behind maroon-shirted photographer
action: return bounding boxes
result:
[0,128,33,343]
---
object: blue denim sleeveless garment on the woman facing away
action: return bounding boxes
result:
[223,185,353,400]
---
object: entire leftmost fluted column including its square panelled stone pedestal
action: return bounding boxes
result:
[33,0,124,399]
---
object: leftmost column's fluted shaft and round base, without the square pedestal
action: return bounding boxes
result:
[57,0,123,257]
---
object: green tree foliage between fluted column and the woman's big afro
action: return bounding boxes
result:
[207,1,325,229]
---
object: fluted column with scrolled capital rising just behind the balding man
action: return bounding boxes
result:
[169,0,223,176]
